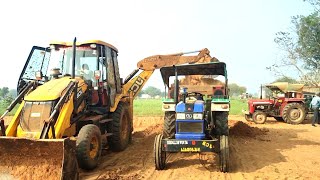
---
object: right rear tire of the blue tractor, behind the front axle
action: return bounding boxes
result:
[214,111,229,136]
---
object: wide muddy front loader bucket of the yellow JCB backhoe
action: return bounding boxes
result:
[0,137,78,180]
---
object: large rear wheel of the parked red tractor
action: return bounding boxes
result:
[282,103,306,124]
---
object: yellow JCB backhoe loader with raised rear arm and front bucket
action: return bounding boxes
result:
[0,39,216,179]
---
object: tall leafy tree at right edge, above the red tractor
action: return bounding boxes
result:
[267,0,320,86]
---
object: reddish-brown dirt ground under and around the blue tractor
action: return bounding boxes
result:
[80,116,320,180]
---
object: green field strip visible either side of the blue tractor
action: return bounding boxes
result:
[133,98,248,116]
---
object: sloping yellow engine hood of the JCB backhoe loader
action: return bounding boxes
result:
[24,77,77,101]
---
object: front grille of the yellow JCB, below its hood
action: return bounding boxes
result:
[20,101,52,132]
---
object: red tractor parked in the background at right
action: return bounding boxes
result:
[243,82,308,124]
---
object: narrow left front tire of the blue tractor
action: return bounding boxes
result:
[153,134,166,170]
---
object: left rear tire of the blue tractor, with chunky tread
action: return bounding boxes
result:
[163,111,176,139]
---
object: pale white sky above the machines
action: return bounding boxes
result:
[0,0,312,93]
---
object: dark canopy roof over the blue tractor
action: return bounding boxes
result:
[160,62,227,85]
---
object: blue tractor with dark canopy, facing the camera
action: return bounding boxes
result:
[154,62,230,172]
